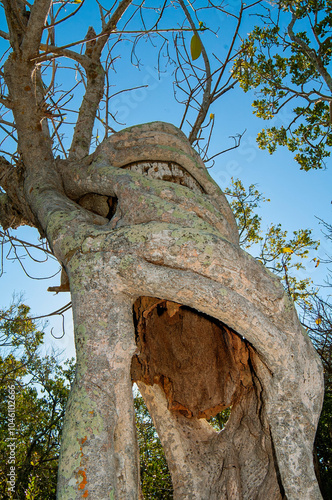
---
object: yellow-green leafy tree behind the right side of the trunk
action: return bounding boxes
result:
[225,179,332,499]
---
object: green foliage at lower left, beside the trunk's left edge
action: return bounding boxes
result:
[0,304,74,499]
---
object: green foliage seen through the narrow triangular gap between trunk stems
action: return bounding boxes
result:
[134,395,173,500]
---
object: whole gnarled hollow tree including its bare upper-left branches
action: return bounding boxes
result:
[0,0,323,500]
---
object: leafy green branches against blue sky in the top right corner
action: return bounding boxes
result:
[233,0,332,170]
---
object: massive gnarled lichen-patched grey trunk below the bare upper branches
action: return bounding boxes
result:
[0,114,322,500]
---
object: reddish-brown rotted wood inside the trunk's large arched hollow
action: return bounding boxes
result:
[132,297,253,419]
